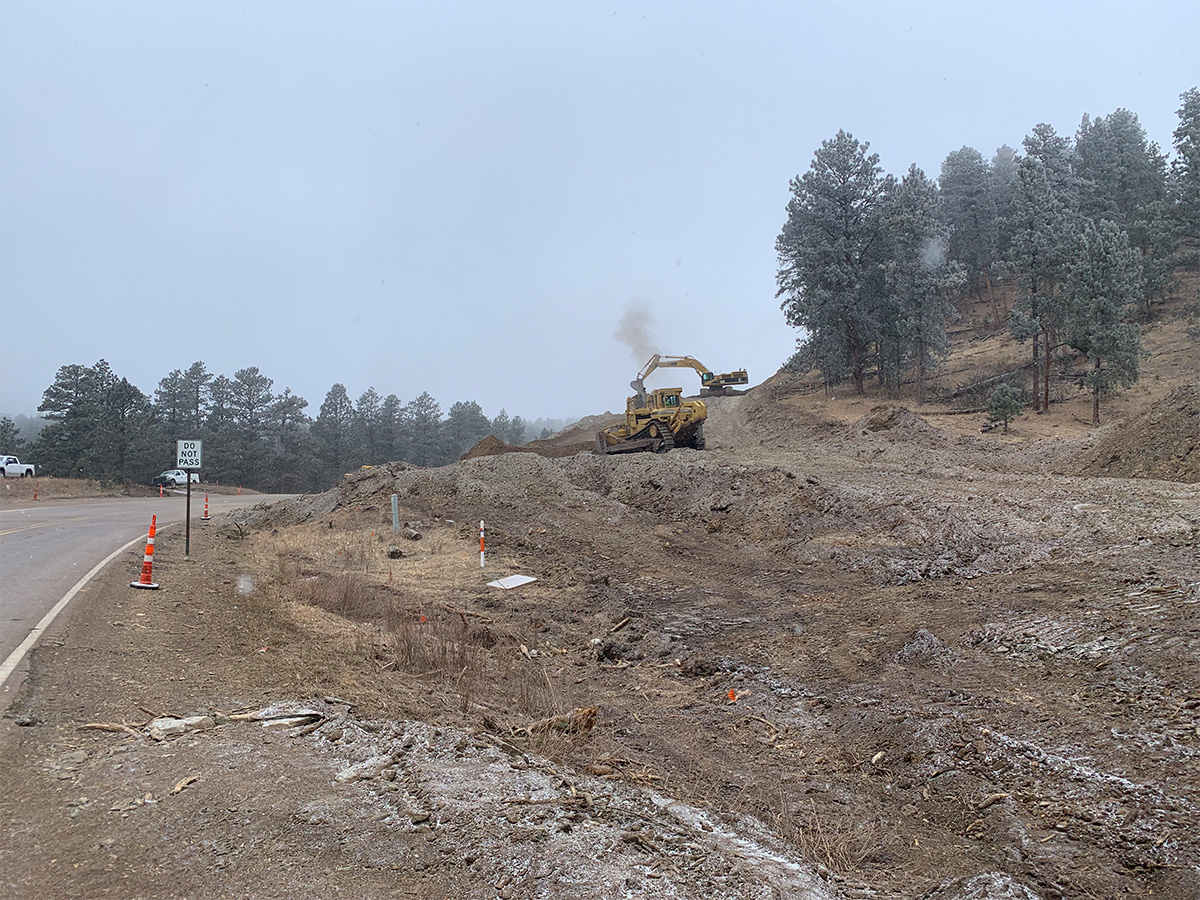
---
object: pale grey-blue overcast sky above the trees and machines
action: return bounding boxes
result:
[0,0,1200,419]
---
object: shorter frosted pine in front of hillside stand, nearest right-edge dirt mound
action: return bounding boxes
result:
[1064,220,1142,425]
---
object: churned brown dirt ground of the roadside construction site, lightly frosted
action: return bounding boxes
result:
[0,300,1200,900]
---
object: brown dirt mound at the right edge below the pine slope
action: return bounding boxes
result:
[1076,384,1200,484]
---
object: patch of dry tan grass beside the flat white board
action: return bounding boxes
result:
[248,514,572,729]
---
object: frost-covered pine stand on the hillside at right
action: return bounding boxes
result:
[775,88,1200,424]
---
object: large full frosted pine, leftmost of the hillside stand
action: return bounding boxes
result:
[775,131,890,394]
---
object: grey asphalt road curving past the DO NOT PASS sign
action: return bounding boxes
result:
[0,492,282,712]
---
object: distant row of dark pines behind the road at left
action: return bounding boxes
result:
[0,360,565,493]
